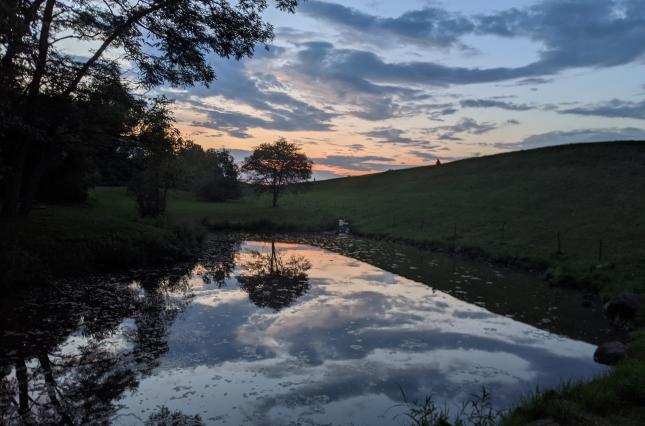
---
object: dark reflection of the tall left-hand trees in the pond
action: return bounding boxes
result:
[0,270,195,425]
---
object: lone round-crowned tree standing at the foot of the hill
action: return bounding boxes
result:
[242,138,313,207]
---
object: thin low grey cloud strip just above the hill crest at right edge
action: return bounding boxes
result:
[495,127,645,149]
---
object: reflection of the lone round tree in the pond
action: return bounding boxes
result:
[237,241,311,311]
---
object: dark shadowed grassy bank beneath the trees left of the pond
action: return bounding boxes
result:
[0,188,205,286]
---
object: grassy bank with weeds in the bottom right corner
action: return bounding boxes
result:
[407,331,645,426]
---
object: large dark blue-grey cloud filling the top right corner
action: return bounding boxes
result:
[476,0,645,76]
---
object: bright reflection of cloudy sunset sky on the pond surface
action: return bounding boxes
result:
[121,242,603,424]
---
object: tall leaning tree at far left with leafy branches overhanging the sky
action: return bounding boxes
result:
[0,0,298,216]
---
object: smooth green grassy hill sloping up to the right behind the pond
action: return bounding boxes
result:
[169,142,645,292]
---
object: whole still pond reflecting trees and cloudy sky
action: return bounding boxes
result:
[0,238,605,425]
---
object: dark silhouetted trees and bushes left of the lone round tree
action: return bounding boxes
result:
[0,0,298,218]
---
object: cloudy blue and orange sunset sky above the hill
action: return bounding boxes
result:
[159,0,645,179]
